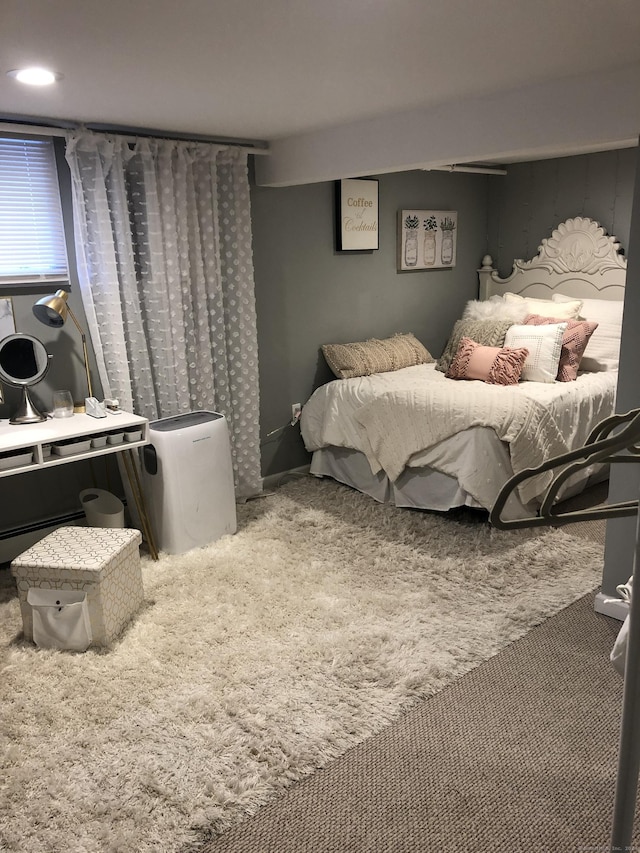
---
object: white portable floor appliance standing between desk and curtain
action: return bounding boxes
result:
[142,411,237,554]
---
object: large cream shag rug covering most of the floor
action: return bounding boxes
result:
[0,478,603,853]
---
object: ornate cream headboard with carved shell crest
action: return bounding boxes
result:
[478,216,627,299]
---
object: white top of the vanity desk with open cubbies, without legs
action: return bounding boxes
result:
[0,412,149,477]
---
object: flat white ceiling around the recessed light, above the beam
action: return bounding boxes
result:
[0,0,640,184]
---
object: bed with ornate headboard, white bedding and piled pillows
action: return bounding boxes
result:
[300,217,626,518]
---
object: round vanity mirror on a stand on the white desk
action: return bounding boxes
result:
[0,332,51,424]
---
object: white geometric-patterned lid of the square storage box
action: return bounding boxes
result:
[11,527,142,574]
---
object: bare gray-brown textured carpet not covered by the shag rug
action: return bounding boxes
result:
[191,480,640,853]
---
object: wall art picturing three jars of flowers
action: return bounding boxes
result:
[398,210,458,270]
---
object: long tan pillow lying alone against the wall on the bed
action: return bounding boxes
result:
[322,333,434,379]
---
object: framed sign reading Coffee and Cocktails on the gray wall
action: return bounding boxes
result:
[336,178,379,252]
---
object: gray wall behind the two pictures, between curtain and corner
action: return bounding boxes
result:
[251,171,490,476]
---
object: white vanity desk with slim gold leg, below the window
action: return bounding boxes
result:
[0,412,158,560]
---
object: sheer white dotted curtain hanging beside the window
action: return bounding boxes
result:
[66,131,261,496]
